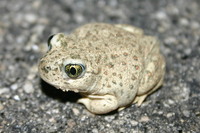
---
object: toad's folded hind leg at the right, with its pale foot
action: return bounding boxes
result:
[134,36,165,105]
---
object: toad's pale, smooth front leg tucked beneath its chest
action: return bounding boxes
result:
[78,95,118,114]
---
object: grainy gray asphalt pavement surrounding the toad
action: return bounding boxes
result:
[0,0,200,133]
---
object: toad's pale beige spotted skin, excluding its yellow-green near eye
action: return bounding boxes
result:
[39,23,165,114]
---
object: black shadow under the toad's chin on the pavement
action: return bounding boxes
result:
[40,79,81,103]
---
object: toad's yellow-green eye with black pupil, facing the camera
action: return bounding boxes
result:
[65,64,85,79]
